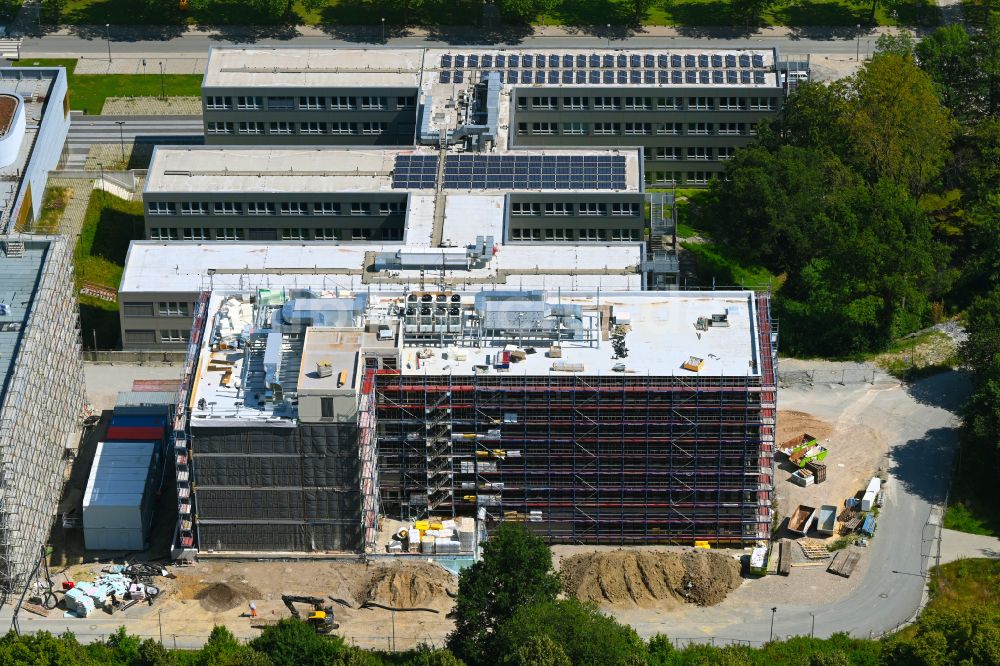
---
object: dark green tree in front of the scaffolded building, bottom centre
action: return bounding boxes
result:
[448,522,560,664]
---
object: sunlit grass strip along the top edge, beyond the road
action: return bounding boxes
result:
[50,0,939,29]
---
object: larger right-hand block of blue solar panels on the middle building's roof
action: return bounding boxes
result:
[444,155,625,190]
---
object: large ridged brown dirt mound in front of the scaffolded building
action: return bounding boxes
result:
[560,550,742,606]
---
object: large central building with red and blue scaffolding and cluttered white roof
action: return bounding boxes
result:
[177,288,777,554]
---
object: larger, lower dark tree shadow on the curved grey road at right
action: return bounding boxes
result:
[889,428,958,504]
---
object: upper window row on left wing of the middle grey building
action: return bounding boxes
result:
[146,201,406,216]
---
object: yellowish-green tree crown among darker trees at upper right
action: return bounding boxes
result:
[843,54,953,193]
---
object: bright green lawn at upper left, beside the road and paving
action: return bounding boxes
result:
[13,58,202,114]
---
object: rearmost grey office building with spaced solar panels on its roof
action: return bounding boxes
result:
[197,48,808,187]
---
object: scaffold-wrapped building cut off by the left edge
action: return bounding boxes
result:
[0,236,84,594]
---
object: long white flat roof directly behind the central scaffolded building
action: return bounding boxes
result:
[119,237,643,294]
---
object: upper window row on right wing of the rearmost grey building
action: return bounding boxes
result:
[517,96,777,111]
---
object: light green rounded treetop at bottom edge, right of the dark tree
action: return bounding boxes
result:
[497,599,646,666]
